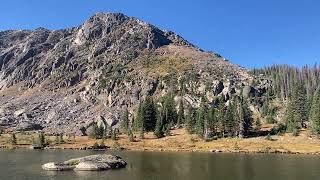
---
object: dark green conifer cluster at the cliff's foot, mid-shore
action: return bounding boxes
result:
[126,93,253,139]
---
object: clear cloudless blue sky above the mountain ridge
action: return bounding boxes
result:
[0,0,320,67]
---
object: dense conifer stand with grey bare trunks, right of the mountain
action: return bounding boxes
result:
[251,65,320,135]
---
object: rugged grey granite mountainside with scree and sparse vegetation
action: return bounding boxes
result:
[0,13,268,134]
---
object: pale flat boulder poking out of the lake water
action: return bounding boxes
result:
[42,154,127,171]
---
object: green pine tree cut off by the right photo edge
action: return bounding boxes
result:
[309,88,320,135]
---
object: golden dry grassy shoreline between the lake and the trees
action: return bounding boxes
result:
[0,129,320,154]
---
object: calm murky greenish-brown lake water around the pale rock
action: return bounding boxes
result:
[0,150,320,180]
